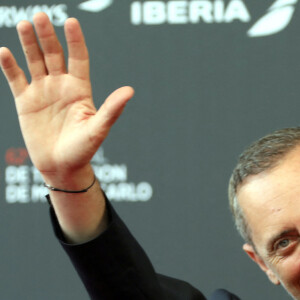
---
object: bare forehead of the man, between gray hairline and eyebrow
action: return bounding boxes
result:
[237,147,300,246]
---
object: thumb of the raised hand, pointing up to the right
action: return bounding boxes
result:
[90,86,134,146]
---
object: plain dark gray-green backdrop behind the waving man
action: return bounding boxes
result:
[0,0,300,300]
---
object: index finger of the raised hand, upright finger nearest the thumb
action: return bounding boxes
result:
[65,18,89,79]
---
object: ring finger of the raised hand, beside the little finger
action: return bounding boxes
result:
[17,21,47,80]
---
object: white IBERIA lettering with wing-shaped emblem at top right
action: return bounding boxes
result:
[131,0,298,37]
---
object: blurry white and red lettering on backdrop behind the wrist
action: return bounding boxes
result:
[5,148,153,204]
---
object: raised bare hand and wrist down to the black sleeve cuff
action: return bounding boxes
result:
[0,13,134,243]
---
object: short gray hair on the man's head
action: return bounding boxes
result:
[228,127,300,246]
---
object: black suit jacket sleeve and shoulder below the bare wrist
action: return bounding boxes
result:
[50,197,239,300]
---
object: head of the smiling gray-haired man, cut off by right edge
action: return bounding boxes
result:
[229,128,300,299]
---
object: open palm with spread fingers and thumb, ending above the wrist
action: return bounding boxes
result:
[0,13,133,173]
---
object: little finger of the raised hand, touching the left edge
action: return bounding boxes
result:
[0,47,28,98]
